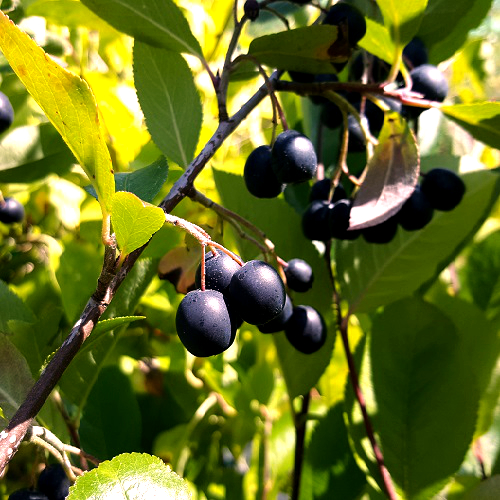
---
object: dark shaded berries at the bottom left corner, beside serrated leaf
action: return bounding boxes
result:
[9,464,71,500]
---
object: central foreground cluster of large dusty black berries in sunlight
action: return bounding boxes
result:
[176,251,326,357]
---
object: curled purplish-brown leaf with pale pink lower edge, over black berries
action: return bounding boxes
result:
[349,113,420,229]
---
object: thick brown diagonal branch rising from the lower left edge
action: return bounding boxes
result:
[0,70,277,477]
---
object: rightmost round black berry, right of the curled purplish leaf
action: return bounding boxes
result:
[421,168,465,211]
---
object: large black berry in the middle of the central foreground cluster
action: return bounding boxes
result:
[229,260,286,325]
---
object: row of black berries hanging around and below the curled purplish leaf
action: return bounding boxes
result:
[302,168,465,243]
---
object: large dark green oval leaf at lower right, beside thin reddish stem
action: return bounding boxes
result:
[348,298,479,500]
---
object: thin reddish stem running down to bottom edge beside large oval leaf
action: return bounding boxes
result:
[325,241,398,500]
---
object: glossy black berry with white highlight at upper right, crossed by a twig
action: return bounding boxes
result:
[403,64,448,118]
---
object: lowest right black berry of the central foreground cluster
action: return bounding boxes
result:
[285,306,327,354]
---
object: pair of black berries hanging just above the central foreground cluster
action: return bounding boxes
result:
[243,130,318,198]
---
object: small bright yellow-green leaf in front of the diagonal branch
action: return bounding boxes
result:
[111,191,165,255]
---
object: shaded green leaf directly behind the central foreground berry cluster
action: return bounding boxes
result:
[213,169,335,398]
